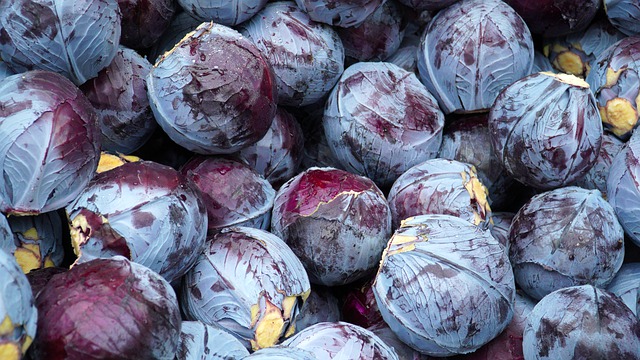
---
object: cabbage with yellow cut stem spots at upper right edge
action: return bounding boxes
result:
[586,36,640,141]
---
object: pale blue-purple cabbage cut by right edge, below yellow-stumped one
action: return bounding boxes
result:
[607,133,640,247]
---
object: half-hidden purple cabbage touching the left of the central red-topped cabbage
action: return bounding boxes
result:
[180,155,276,232]
